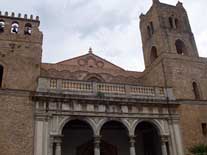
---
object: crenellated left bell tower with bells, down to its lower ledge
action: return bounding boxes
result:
[0,12,43,91]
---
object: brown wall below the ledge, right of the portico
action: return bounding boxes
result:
[179,101,207,154]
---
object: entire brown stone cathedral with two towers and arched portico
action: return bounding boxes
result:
[0,0,207,155]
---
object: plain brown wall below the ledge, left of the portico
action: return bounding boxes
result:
[0,91,34,155]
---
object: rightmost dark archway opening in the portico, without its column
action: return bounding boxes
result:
[135,122,162,155]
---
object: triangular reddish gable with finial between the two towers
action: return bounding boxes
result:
[56,49,124,71]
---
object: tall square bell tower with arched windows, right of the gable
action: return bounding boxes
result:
[140,0,198,68]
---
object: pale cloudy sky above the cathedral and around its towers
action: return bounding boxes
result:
[0,0,207,71]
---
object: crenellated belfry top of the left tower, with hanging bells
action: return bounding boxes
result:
[0,11,42,42]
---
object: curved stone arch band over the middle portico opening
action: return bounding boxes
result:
[96,118,130,135]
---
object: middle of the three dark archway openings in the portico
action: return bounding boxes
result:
[101,121,129,155]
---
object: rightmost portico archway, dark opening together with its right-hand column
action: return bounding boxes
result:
[134,120,169,155]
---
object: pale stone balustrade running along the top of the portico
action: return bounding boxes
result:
[37,78,174,99]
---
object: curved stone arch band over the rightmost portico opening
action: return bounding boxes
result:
[131,119,165,135]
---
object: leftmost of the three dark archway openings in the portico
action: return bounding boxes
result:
[62,120,94,155]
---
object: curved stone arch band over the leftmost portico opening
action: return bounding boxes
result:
[57,117,96,135]
